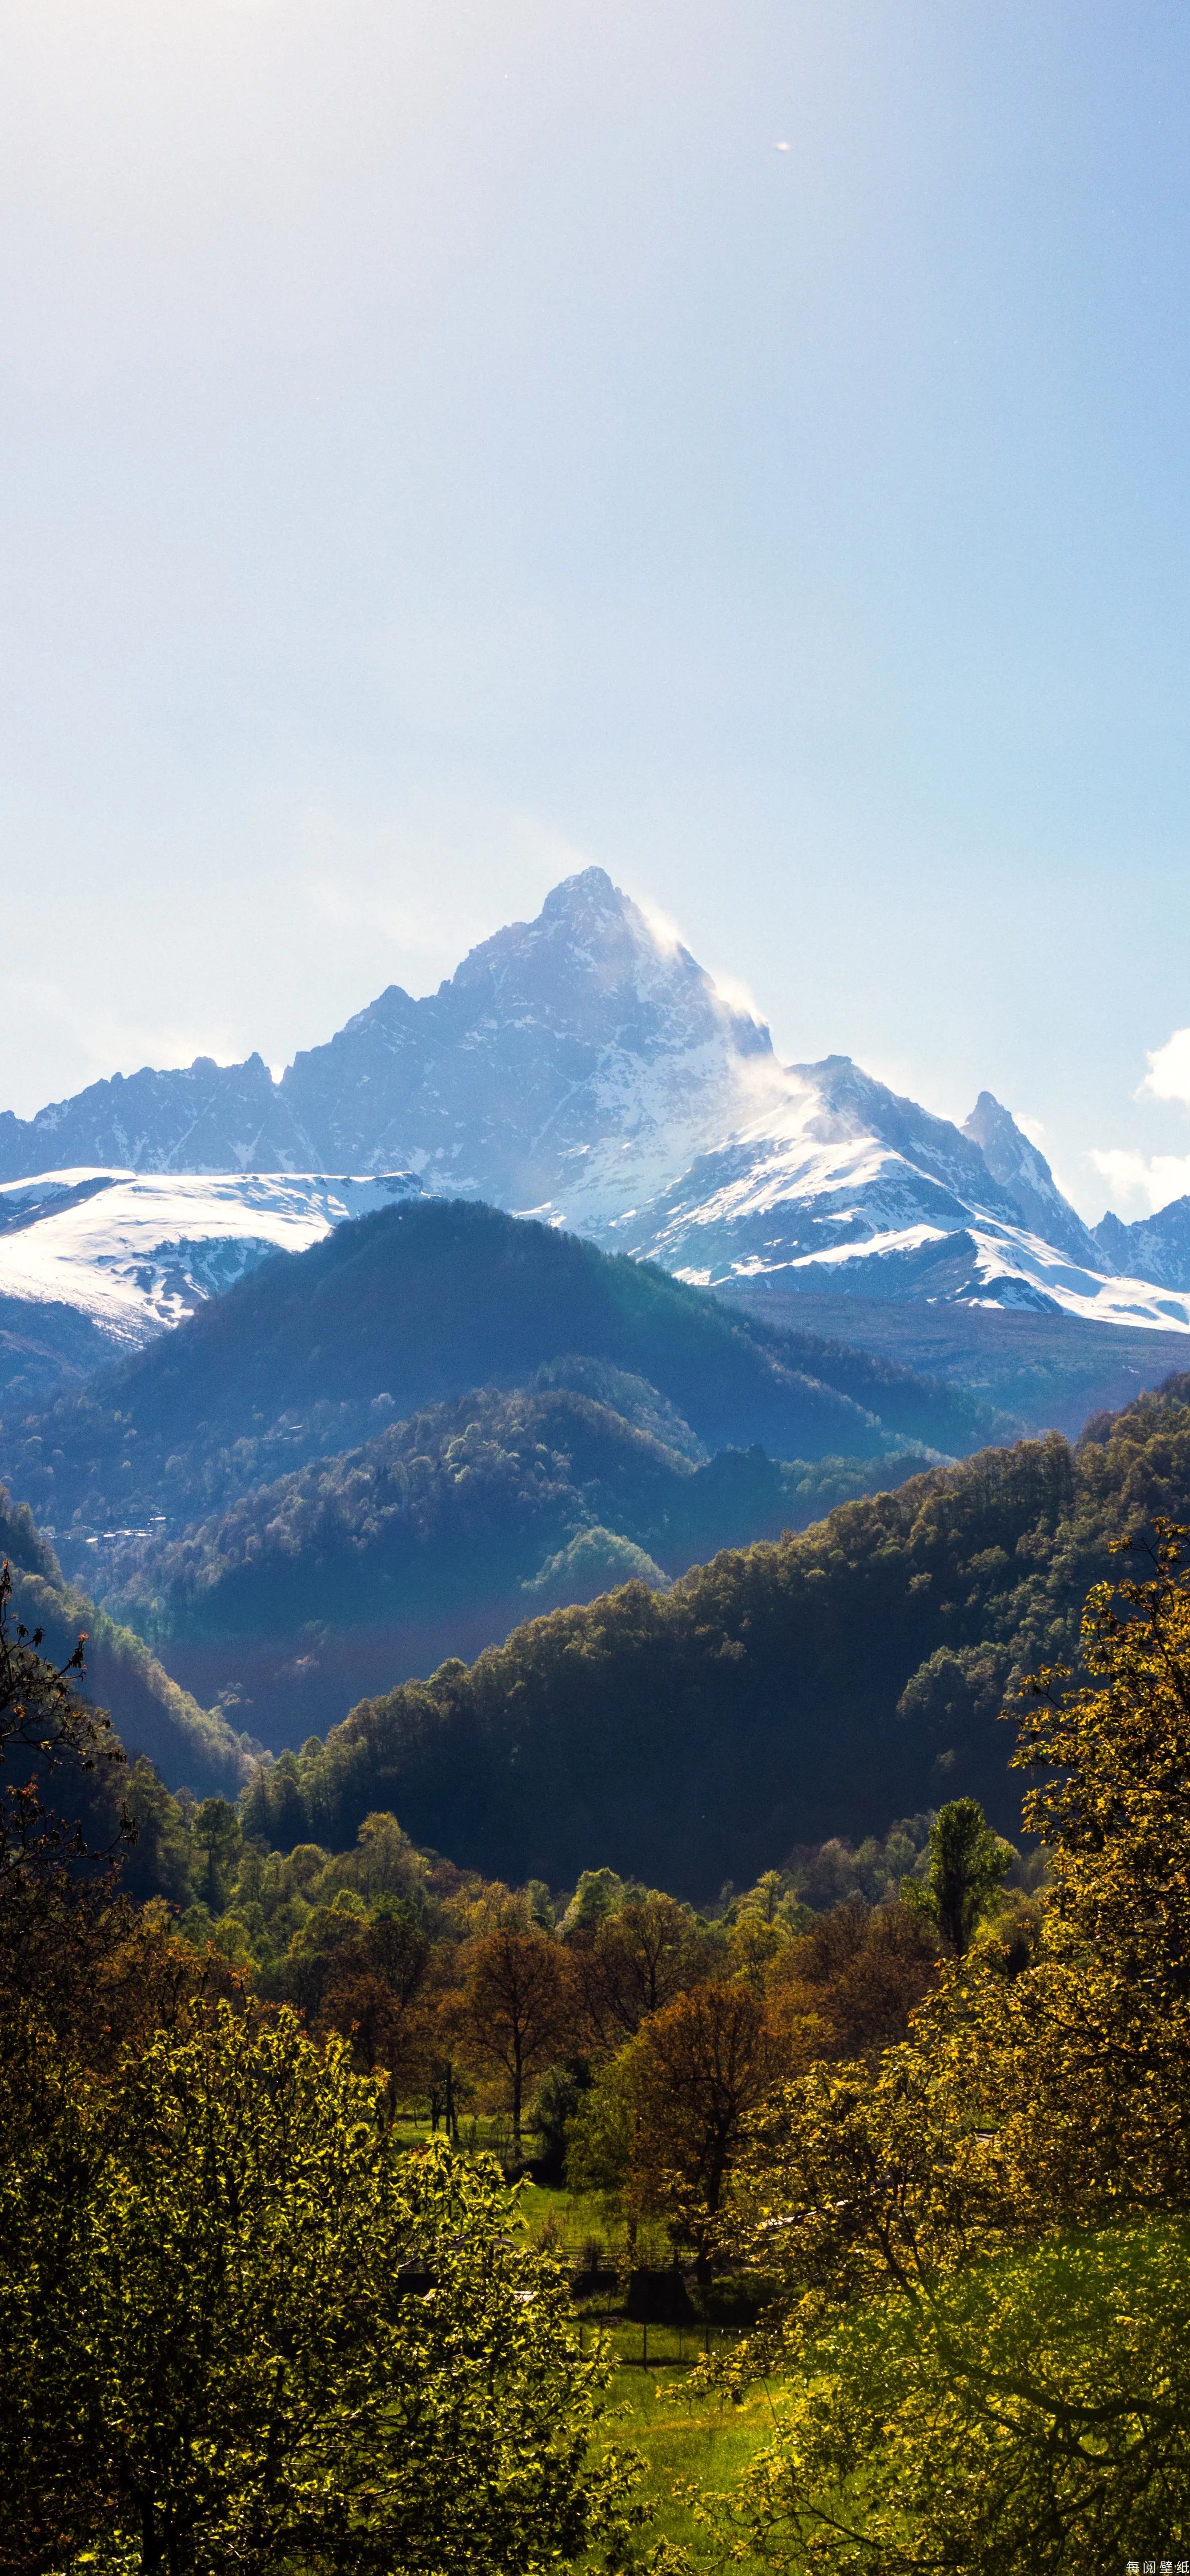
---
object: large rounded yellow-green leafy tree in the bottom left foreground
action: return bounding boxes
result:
[0,2009,641,2576]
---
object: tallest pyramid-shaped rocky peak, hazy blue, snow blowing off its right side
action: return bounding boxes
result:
[281,868,778,1226]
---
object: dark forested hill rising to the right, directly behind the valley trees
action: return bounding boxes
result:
[250,1375,1190,1898]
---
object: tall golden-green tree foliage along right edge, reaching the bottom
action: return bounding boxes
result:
[706,1522,1190,2576]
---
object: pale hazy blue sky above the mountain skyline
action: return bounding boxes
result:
[0,0,1190,1216]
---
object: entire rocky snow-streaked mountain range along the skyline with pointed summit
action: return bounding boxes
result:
[0,868,1190,1332]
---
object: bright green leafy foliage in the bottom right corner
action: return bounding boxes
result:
[711,2223,1190,2576]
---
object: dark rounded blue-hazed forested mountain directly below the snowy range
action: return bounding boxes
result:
[0,1201,1002,1543]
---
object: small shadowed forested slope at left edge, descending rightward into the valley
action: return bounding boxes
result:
[0,1486,250,1795]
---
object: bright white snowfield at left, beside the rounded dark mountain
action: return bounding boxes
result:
[0,1167,422,1347]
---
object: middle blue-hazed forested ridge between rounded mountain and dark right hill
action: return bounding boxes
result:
[103,1360,925,1749]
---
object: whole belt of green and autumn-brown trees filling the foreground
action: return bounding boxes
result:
[0,1517,1190,2576]
